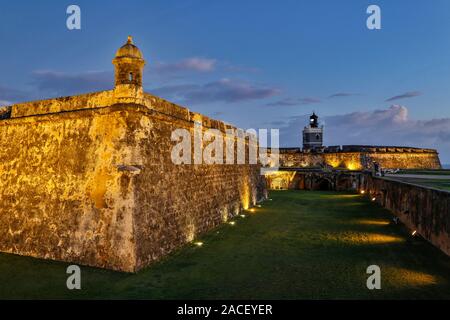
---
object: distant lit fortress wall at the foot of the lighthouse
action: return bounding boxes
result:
[280,145,441,170]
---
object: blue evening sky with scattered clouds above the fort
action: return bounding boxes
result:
[0,0,450,163]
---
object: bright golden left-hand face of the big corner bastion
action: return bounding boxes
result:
[0,109,136,270]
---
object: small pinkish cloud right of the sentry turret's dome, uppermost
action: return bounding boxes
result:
[154,57,217,75]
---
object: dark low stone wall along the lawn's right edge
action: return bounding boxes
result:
[362,175,450,255]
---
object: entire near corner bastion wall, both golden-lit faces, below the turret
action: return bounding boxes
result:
[0,99,266,271]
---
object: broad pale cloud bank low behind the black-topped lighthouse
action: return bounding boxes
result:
[280,105,450,163]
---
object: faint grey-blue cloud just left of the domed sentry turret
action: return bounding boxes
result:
[32,70,114,96]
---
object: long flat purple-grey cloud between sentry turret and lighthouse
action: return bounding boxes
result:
[151,79,280,104]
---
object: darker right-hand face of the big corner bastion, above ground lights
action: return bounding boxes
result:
[122,105,267,268]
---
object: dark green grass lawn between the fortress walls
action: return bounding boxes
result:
[0,191,450,299]
